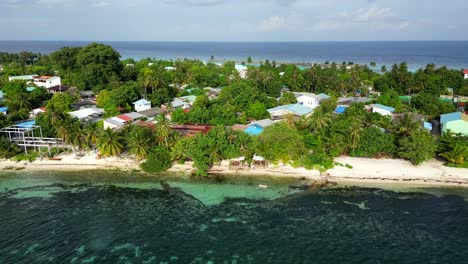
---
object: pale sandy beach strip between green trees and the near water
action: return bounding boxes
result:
[0,153,468,188]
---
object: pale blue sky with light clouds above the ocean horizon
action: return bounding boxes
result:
[0,0,468,41]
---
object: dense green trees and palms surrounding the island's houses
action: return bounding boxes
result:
[0,43,468,175]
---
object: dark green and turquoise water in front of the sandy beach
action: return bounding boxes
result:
[0,172,468,263]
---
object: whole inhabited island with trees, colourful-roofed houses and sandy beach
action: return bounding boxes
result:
[0,43,468,186]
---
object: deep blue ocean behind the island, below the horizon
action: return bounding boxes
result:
[0,41,468,69]
